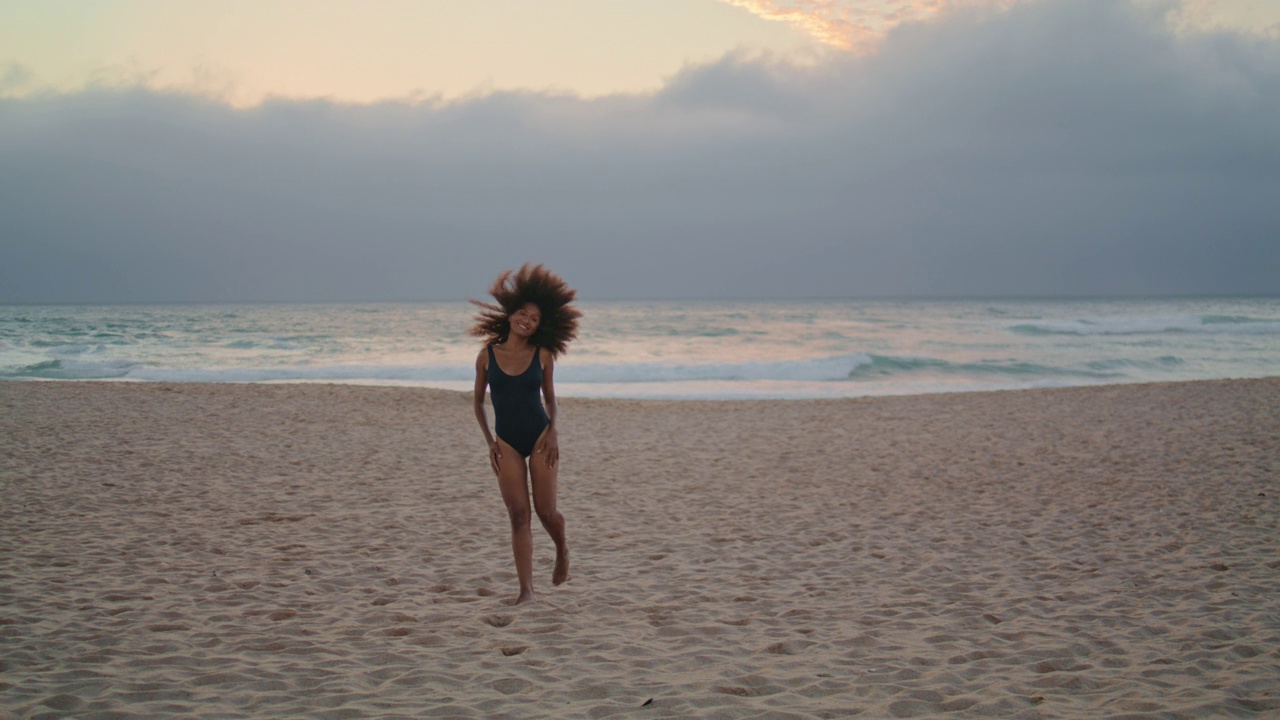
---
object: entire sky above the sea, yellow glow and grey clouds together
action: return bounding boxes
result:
[0,0,1280,302]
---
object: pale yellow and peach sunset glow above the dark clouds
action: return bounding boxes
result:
[0,0,1280,106]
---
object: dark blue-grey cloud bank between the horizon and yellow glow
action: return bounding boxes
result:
[0,0,1280,302]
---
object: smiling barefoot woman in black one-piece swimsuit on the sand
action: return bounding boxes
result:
[471,263,582,605]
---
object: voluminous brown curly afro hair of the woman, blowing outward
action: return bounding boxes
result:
[468,263,582,355]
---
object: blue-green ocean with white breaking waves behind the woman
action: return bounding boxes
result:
[0,297,1280,398]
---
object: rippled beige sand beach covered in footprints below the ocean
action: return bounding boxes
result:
[0,379,1280,719]
